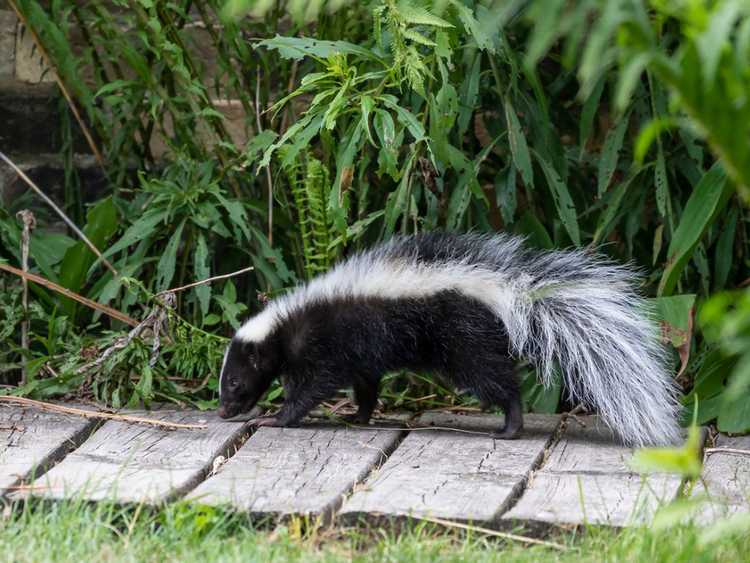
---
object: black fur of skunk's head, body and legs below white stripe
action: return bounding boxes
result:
[219,288,523,438]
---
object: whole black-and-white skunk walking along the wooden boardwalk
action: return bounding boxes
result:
[219,232,680,446]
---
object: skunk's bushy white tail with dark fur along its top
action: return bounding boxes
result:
[384,233,680,446]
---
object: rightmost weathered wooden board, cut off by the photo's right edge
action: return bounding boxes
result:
[693,436,750,522]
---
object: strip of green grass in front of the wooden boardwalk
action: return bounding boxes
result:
[0,502,750,563]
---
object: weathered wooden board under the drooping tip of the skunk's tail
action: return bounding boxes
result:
[503,417,681,526]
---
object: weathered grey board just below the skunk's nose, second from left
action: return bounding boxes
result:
[25,410,247,503]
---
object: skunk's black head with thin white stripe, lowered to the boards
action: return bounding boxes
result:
[219,337,278,418]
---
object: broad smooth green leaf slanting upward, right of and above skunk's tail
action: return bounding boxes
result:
[658,162,731,295]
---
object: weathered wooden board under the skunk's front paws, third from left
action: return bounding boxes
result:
[189,423,402,516]
